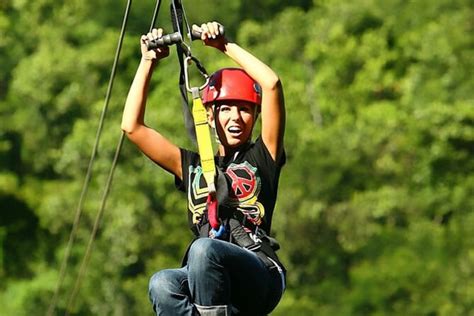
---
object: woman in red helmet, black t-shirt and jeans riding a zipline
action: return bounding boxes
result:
[122,22,286,315]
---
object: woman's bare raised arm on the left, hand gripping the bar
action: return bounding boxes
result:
[121,29,182,179]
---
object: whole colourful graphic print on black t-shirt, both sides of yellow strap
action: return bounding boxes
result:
[188,162,265,226]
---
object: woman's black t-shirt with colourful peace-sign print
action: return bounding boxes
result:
[175,137,285,235]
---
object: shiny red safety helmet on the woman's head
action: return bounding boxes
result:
[202,68,262,105]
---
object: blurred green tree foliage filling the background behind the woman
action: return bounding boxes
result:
[0,0,474,315]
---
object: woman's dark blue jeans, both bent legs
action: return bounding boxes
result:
[149,238,283,316]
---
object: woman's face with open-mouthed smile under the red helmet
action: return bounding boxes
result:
[209,101,256,149]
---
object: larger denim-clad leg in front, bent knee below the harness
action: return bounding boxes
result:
[187,238,281,315]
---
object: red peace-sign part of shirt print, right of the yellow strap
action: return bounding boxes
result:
[226,161,265,226]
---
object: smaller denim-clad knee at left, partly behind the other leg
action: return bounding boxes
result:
[148,268,196,316]
